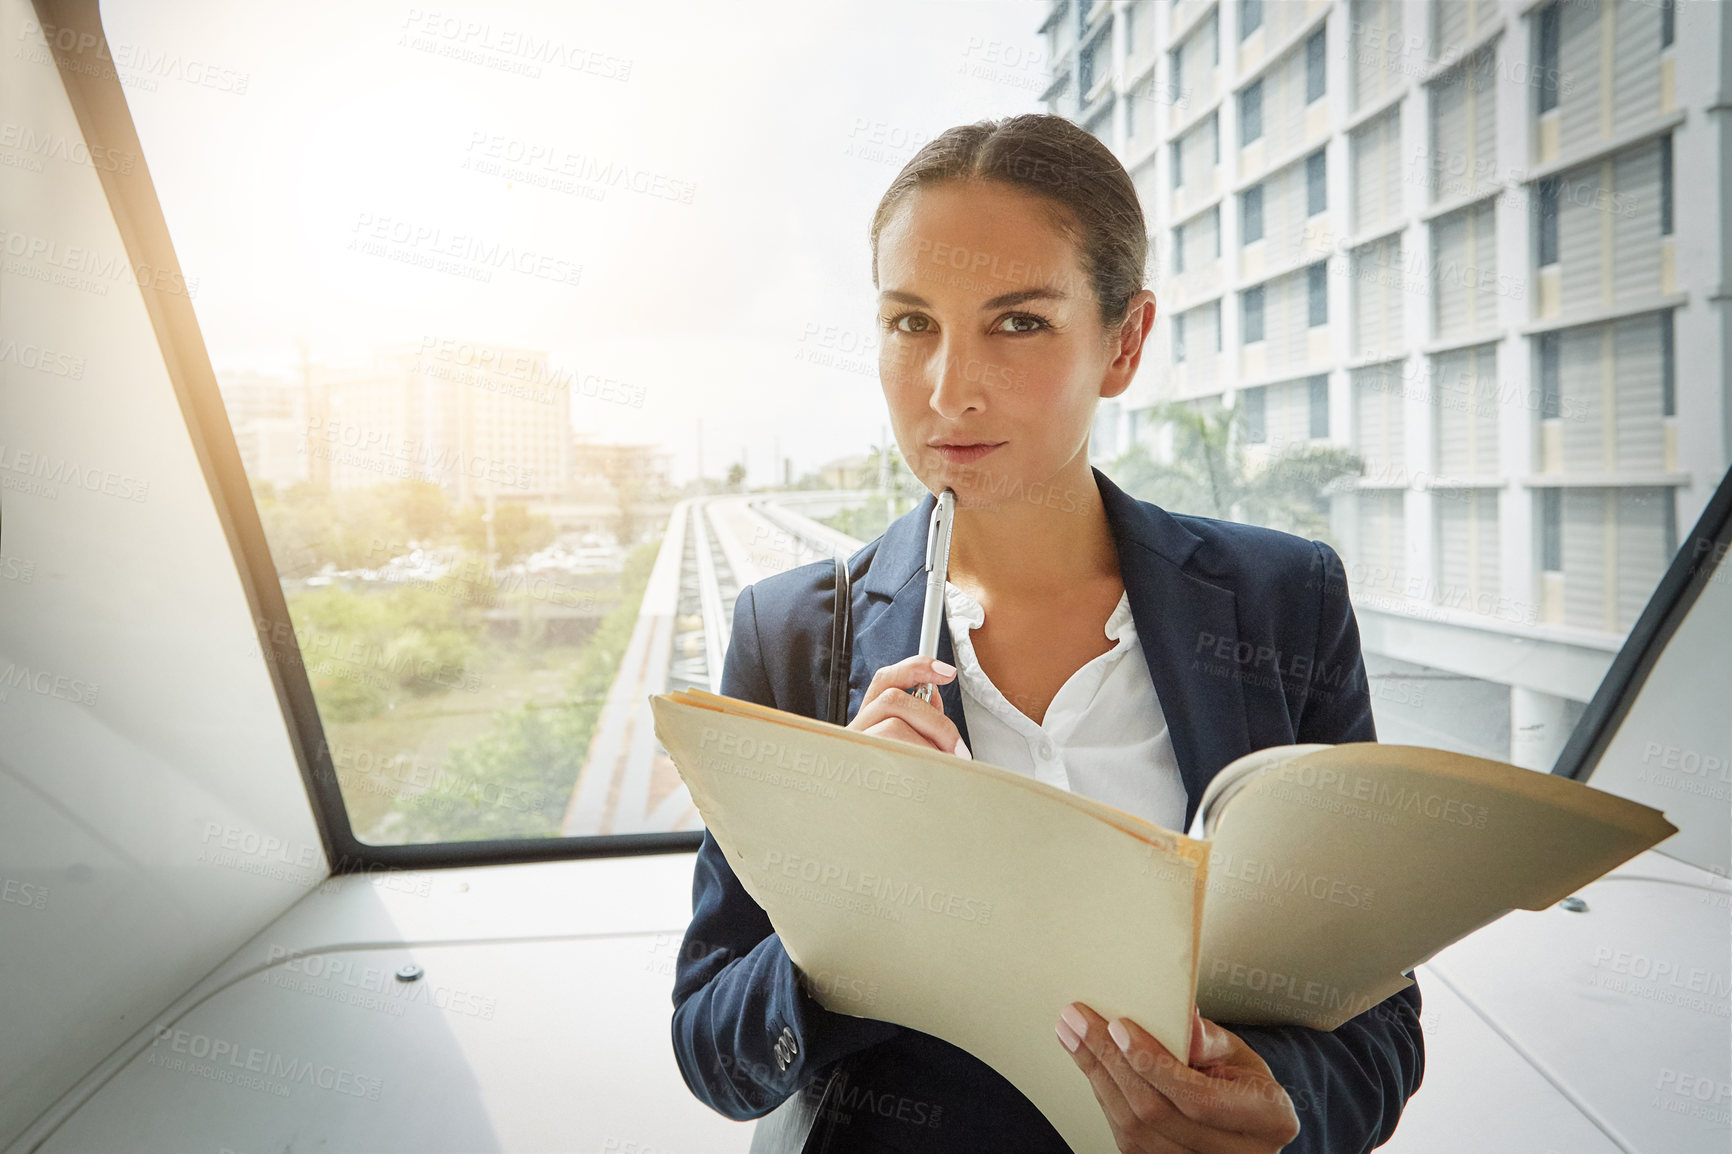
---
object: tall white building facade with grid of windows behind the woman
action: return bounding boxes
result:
[1041,0,1732,769]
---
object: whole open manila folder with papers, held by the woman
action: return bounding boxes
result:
[650,690,1677,1154]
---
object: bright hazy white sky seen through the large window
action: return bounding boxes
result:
[102,0,1050,485]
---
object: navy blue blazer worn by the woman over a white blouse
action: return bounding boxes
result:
[672,470,1425,1154]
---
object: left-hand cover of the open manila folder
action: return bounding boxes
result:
[650,690,1209,1154]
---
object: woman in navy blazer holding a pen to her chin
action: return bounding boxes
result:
[672,114,1424,1154]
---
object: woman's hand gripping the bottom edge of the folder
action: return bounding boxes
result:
[1058,1002,1299,1154]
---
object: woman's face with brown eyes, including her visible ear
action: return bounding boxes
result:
[878,182,1154,508]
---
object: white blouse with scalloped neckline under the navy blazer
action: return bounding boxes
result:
[944,582,1186,832]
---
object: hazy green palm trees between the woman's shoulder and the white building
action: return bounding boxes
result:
[1112,402,1365,544]
